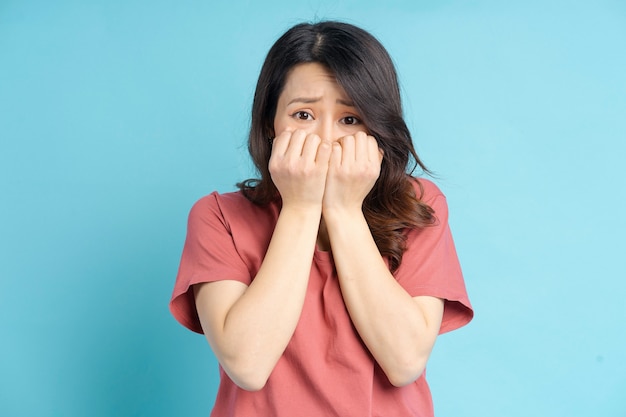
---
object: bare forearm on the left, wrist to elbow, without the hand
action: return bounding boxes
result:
[197,208,320,390]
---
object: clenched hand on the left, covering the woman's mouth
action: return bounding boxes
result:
[269,129,332,208]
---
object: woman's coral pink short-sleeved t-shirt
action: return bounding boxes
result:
[170,179,473,417]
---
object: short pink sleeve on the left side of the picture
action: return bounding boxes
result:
[170,193,251,333]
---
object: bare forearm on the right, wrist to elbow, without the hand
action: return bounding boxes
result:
[324,210,442,386]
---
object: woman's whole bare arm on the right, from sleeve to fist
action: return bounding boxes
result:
[323,134,443,386]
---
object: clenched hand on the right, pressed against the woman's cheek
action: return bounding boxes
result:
[323,132,383,213]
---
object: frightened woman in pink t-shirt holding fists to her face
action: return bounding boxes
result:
[170,22,473,417]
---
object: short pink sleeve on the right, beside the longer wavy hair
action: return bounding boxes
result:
[395,180,474,333]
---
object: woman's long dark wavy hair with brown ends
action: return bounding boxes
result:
[237,21,435,272]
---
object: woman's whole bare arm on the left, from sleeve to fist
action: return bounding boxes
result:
[194,132,330,390]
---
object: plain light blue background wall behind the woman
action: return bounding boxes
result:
[0,0,626,417]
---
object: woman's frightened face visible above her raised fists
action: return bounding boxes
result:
[274,63,367,142]
